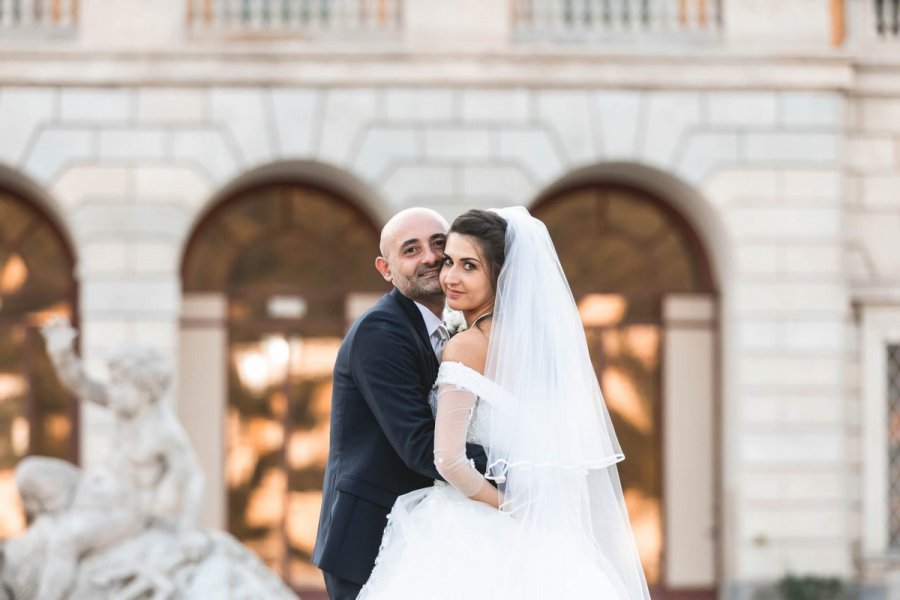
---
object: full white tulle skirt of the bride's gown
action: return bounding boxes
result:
[358,483,625,600]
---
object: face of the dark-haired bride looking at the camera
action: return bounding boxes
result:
[441,233,494,316]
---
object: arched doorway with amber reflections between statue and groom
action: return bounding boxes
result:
[179,183,386,590]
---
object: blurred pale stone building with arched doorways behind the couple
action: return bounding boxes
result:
[0,0,900,599]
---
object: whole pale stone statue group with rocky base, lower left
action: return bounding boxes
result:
[0,319,296,600]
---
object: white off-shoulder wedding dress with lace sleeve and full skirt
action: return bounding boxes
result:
[359,362,629,600]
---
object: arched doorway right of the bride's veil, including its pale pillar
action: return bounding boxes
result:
[532,182,718,598]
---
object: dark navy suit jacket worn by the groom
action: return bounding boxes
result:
[312,289,487,584]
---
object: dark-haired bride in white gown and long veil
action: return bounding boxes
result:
[359,207,649,600]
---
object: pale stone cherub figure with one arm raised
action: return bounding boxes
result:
[37,318,209,600]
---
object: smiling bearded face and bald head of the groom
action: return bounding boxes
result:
[376,212,447,301]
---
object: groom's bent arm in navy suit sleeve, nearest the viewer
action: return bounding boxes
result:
[350,313,442,479]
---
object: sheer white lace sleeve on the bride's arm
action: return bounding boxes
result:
[434,383,498,506]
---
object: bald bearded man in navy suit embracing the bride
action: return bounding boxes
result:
[312,208,487,600]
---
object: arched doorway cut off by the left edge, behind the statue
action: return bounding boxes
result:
[0,190,78,538]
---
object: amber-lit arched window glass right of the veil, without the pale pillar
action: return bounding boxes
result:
[533,184,715,591]
